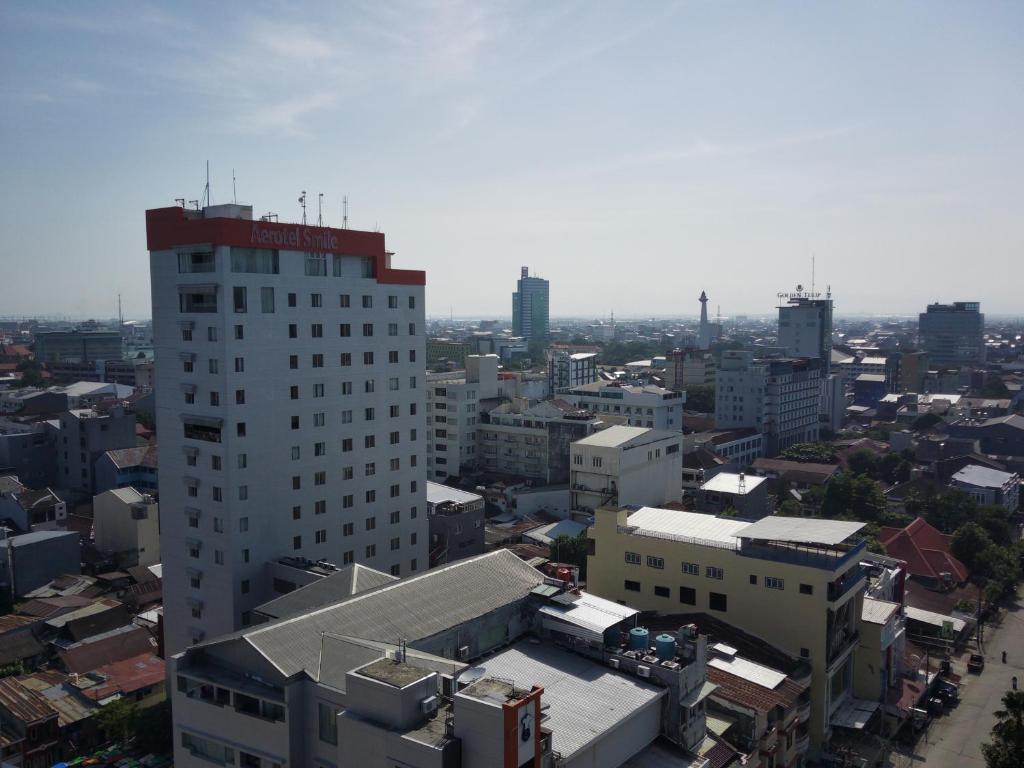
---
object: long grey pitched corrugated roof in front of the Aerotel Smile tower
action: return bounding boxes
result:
[220,550,544,675]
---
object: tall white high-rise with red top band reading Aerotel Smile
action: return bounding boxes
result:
[146,205,428,653]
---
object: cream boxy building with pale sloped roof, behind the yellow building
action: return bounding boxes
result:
[569,426,683,515]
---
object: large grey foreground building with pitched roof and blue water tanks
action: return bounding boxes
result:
[168,551,714,768]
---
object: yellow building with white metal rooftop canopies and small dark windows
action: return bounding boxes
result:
[587,507,865,752]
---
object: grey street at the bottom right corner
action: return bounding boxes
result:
[913,592,1024,768]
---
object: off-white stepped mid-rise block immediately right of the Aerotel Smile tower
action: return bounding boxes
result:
[426,354,499,480]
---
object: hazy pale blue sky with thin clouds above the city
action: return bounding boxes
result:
[0,0,1024,316]
